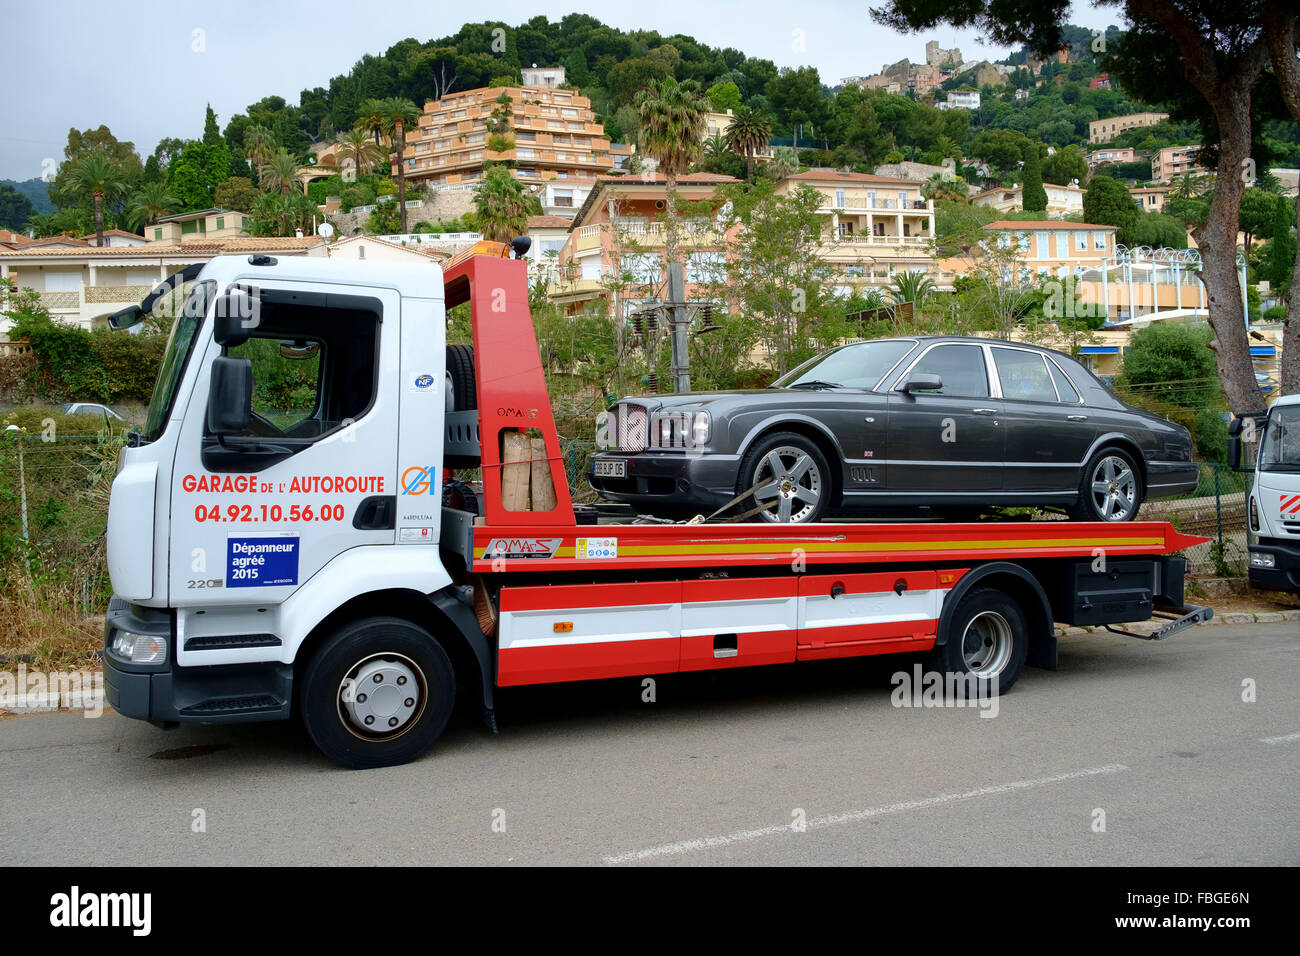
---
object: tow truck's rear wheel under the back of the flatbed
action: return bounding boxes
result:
[930,588,1030,697]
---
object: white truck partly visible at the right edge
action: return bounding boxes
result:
[1229,395,1300,594]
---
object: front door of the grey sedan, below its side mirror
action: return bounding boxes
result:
[888,342,1002,499]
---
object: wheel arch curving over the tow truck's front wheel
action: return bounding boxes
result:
[294,587,495,717]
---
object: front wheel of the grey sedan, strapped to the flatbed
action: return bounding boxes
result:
[736,432,832,524]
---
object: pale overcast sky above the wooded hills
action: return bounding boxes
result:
[0,0,1118,179]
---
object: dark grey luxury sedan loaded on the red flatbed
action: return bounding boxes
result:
[590,336,1197,522]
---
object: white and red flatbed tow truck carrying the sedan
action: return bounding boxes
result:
[103,247,1209,769]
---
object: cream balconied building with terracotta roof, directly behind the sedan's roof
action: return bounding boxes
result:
[776,169,953,290]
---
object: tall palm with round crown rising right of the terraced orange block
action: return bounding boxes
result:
[636,77,711,273]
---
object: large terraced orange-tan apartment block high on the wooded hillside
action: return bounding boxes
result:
[402,86,614,196]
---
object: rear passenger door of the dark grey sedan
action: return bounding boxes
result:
[991,345,1097,493]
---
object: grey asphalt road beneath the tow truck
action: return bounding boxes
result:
[0,623,1300,866]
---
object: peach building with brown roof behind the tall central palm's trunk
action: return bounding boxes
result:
[543,173,736,315]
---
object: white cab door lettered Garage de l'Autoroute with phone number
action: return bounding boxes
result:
[168,277,400,621]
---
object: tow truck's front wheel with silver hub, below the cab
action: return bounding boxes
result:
[300,618,456,770]
